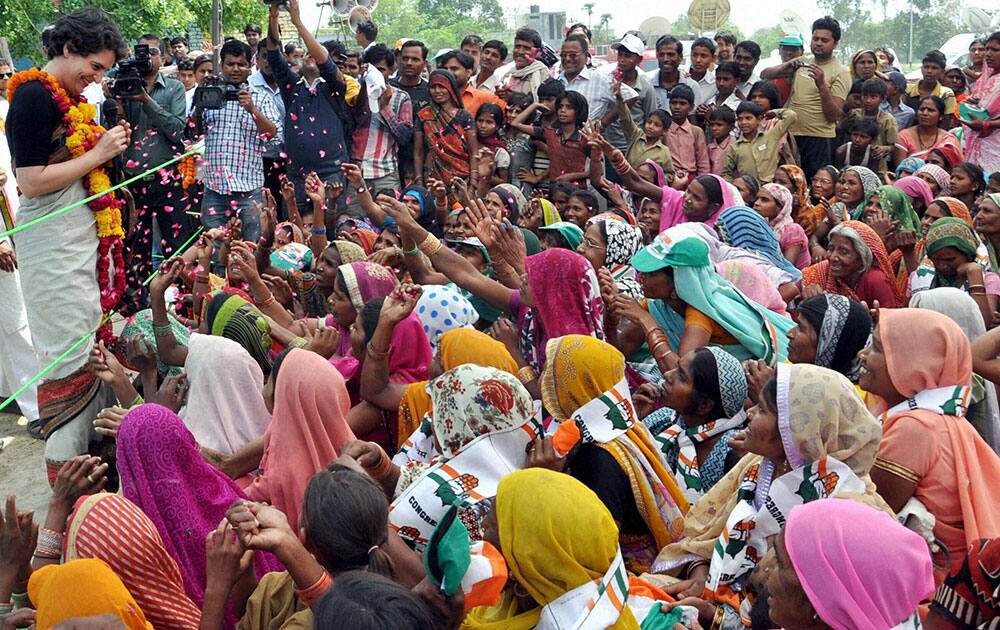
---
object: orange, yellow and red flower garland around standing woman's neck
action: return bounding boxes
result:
[7,68,125,342]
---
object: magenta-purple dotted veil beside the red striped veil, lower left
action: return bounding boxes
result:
[117,403,282,630]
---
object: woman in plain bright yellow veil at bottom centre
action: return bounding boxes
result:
[462,468,639,630]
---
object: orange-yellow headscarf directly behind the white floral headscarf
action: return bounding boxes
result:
[397,328,517,446]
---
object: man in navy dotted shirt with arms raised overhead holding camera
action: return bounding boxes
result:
[267,0,348,217]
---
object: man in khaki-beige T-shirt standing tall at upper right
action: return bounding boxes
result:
[760,16,851,180]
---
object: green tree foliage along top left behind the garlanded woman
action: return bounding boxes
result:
[0,0,267,61]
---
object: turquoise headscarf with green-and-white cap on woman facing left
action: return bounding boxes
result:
[632,237,795,365]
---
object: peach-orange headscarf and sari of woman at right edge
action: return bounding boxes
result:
[878,308,1000,545]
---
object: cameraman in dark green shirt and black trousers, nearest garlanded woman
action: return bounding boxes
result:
[110,34,194,310]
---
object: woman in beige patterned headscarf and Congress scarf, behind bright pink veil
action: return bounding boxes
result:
[643,363,889,629]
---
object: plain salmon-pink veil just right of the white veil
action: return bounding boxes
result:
[246,349,355,527]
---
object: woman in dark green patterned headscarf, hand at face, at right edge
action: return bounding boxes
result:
[910,217,1000,322]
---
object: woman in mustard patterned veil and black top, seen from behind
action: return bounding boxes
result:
[540,335,688,574]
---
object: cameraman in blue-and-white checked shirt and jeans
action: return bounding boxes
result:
[194,39,282,241]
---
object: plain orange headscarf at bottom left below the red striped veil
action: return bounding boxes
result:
[28,558,153,630]
